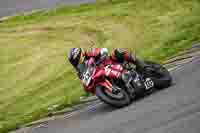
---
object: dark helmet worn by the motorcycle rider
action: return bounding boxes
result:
[68,48,82,67]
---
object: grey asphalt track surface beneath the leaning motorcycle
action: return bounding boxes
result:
[17,58,200,133]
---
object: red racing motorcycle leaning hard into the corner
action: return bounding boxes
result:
[81,58,172,107]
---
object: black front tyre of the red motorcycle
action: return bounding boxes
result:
[96,86,131,108]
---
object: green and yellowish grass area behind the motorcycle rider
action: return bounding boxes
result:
[0,0,200,132]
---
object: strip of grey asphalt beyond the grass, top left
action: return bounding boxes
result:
[0,0,96,17]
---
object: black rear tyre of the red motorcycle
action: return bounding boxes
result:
[145,61,172,89]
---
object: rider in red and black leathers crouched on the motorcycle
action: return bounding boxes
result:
[68,48,148,93]
